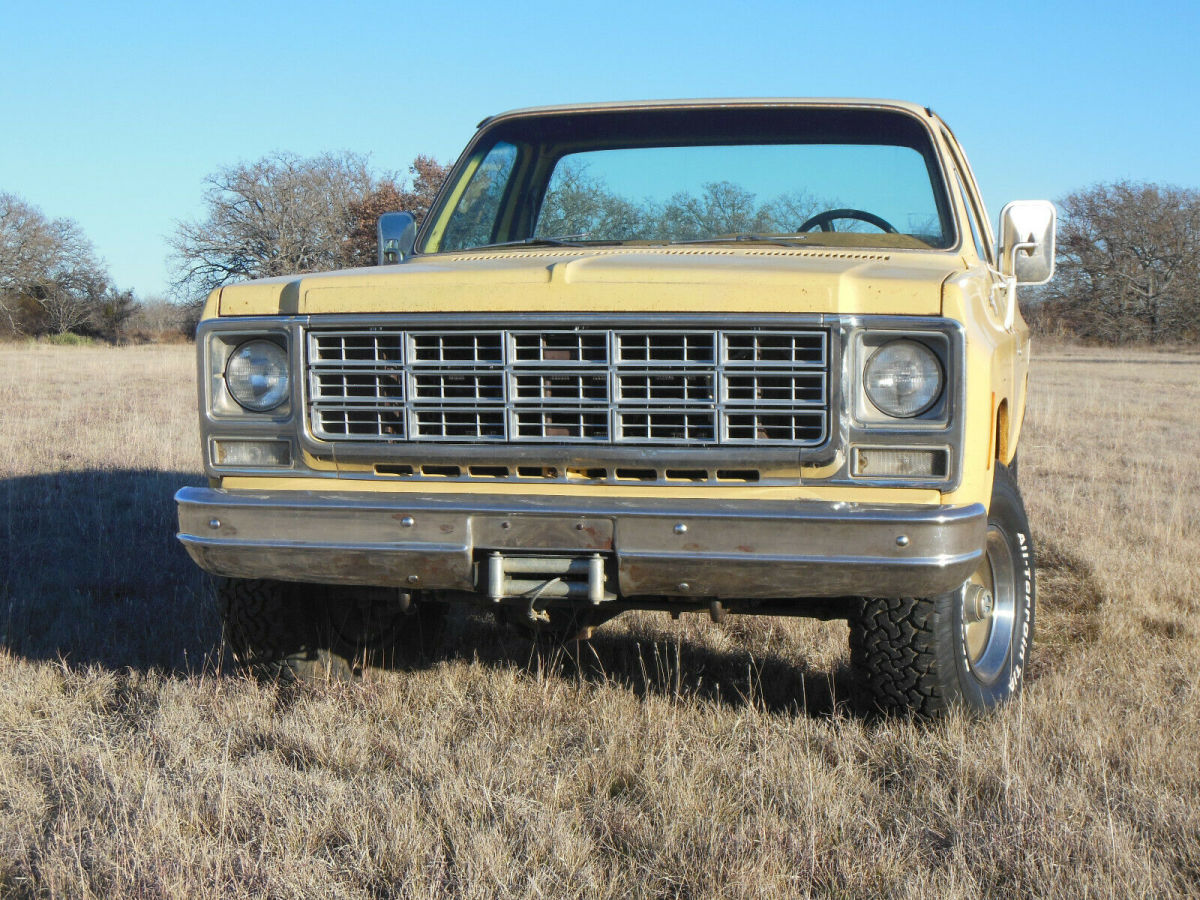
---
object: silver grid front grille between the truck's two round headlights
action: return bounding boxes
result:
[306,326,829,446]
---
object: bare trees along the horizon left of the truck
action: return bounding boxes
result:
[0,152,449,342]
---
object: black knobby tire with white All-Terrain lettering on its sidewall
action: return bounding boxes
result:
[850,464,1036,718]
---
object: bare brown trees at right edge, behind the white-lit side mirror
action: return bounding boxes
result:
[1031,181,1200,343]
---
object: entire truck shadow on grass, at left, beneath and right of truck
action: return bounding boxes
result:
[0,469,1100,715]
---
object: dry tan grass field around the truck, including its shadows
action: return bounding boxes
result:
[0,344,1200,898]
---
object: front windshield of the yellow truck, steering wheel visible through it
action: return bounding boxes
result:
[421,107,955,252]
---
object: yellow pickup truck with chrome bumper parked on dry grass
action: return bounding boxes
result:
[176,100,1055,715]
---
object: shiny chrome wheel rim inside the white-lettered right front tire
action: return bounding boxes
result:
[960,526,1016,682]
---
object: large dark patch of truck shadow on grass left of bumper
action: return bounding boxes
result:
[0,469,221,673]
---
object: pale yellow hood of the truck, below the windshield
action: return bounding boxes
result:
[220,246,965,316]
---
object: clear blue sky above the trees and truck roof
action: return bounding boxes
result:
[0,0,1200,298]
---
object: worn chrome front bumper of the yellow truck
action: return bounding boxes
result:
[175,487,986,605]
